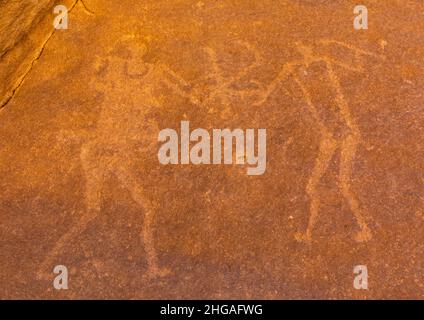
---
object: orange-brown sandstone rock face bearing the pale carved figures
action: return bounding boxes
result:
[0,0,424,299]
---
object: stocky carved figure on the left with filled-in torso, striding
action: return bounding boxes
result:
[39,40,196,278]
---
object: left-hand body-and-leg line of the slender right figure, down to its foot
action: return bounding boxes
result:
[294,76,337,242]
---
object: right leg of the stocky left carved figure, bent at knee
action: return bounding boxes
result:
[115,166,170,278]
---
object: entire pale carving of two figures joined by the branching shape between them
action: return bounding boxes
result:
[39,40,384,277]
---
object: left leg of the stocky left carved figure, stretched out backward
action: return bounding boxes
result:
[38,144,104,279]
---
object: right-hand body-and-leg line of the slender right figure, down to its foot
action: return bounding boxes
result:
[327,63,372,242]
